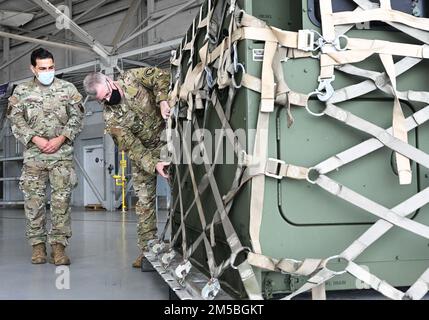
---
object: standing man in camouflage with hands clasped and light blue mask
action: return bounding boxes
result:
[8,49,83,265]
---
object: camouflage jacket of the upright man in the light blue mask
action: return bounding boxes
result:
[7,78,84,162]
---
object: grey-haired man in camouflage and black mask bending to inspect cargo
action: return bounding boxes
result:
[84,67,170,270]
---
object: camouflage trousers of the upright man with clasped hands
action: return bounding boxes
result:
[19,161,77,246]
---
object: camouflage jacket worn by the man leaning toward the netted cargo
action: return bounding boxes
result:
[104,67,170,174]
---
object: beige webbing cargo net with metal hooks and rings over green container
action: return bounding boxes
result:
[151,0,429,299]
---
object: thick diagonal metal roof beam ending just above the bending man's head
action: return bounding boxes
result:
[32,0,110,63]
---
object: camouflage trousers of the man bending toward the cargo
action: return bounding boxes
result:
[132,164,157,251]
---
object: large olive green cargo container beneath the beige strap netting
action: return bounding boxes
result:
[166,0,429,298]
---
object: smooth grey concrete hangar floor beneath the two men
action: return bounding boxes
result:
[0,209,168,300]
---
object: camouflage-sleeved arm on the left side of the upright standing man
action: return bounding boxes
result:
[6,86,36,146]
